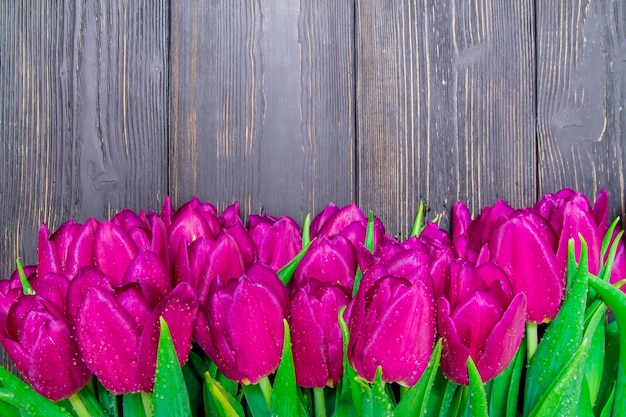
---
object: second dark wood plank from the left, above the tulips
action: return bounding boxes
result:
[170,0,355,222]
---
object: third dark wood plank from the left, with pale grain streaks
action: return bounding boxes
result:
[357,0,536,236]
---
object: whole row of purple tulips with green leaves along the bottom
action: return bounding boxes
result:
[0,189,626,417]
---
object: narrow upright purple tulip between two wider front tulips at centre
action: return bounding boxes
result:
[288,284,350,388]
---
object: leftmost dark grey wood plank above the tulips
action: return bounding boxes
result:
[0,0,169,364]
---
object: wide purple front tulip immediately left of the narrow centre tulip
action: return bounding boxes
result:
[195,263,287,384]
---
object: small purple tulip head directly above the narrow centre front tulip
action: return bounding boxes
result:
[293,235,357,293]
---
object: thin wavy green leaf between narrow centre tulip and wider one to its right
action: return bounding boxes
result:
[334,307,362,417]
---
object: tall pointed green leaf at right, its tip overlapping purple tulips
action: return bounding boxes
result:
[524,236,588,417]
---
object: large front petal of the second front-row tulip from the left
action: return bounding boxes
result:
[76,288,143,394]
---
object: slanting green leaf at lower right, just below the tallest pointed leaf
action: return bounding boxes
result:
[529,290,604,417]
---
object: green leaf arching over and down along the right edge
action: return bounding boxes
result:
[589,276,626,416]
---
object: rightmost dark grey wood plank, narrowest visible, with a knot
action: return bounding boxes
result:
[537,0,626,224]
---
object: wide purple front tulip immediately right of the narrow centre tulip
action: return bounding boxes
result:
[348,276,435,386]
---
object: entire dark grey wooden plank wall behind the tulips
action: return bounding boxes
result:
[0,0,626,364]
